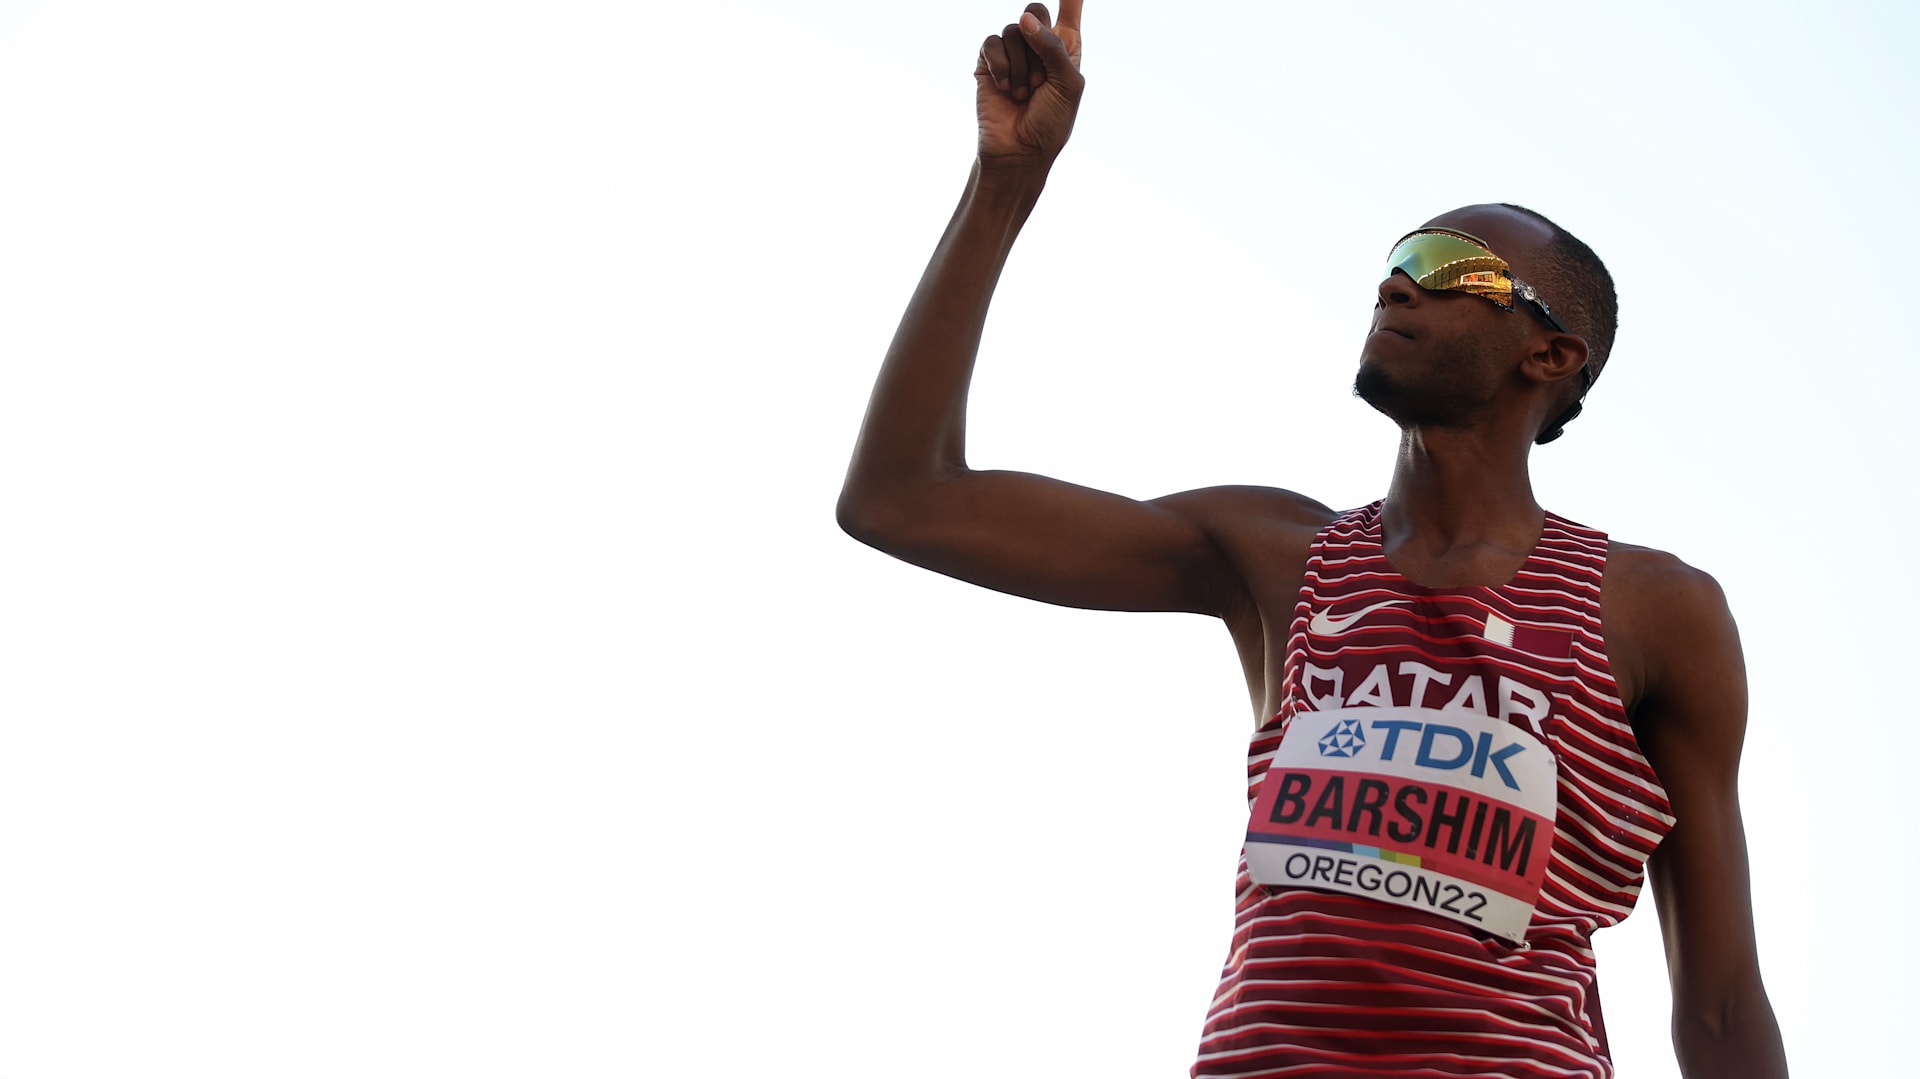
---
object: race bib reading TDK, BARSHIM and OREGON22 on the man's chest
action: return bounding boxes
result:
[1246,708,1559,943]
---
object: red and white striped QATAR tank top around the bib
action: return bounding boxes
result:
[1192,503,1672,1079]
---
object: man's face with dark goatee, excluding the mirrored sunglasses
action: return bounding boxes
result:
[1354,205,1551,428]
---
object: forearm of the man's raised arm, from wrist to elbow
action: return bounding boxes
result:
[841,161,1046,520]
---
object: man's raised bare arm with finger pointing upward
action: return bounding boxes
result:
[839,0,1320,614]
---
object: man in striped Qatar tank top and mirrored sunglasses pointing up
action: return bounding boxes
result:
[839,0,1786,1079]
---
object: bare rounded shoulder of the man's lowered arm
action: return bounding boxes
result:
[1599,541,1743,712]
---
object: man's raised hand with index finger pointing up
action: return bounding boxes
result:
[973,0,1087,169]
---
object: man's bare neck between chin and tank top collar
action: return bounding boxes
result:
[1380,420,1546,572]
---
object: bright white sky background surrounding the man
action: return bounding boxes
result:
[0,0,1920,1079]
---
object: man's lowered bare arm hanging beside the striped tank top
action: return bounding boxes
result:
[1607,551,1788,1079]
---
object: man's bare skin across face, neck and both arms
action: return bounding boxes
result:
[839,0,1786,1079]
